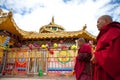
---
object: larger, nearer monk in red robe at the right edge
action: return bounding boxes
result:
[91,15,120,80]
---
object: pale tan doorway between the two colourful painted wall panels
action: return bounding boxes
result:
[28,50,47,74]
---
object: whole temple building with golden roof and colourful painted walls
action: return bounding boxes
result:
[0,9,96,76]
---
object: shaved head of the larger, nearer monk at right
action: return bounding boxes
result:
[97,15,113,30]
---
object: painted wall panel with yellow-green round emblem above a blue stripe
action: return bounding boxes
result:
[47,50,76,75]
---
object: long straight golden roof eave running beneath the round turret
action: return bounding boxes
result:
[23,30,95,40]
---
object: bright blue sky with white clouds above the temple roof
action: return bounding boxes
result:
[0,0,120,35]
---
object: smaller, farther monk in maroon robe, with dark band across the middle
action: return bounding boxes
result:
[74,38,92,80]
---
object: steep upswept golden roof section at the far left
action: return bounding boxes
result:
[0,12,22,36]
